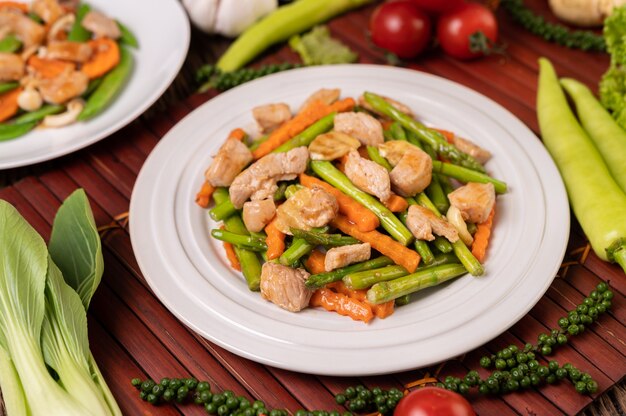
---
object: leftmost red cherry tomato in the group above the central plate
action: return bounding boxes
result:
[369,0,432,58]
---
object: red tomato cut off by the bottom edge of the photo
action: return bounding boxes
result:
[393,387,476,416]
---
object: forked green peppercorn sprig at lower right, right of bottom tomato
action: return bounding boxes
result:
[439,282,613,394]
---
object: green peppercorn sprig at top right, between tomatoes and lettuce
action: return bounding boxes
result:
[500,0,606,52]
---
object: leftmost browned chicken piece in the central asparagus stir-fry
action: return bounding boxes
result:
[204,139,253,186]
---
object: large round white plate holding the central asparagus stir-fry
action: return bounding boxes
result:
[130,65,569,376]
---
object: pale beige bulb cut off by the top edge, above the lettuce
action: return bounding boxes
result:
[549,0,626,26]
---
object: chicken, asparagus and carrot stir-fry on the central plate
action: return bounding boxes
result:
[196,89,506,322]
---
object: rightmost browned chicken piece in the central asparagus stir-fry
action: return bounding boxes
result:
[448,182,496,224]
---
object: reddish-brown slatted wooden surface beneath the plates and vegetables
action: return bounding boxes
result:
[0,1,626,415]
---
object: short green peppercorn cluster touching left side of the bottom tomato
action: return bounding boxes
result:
[334,386,403,416]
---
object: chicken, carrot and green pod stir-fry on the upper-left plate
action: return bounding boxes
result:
[0,0,137,141]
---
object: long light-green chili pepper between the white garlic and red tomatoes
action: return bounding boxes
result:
[217,0,372,72]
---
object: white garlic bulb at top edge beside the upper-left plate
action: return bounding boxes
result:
[183,0,278,37]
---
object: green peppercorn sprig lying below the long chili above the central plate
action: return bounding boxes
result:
[196,62,302,91]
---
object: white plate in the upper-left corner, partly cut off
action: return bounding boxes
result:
[0,0,190,169]
